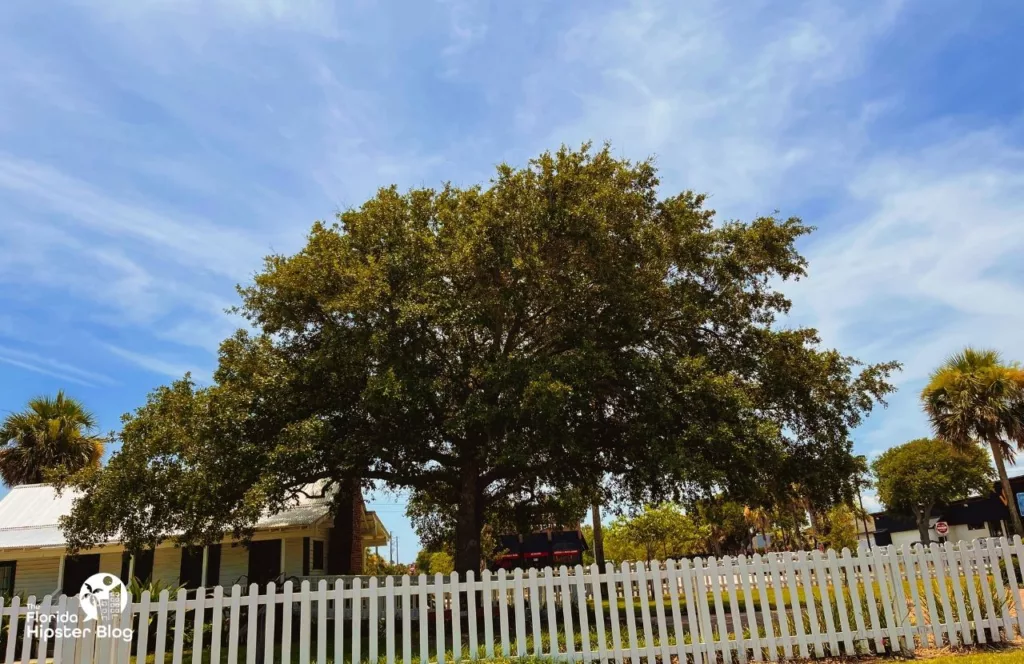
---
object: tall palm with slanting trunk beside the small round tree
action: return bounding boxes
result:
[921,347,1024,536]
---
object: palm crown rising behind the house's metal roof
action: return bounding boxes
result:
[0,390,106,487]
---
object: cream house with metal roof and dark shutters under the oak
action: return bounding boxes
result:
[0,485,389,597]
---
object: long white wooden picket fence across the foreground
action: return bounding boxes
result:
[0,538,1024,664]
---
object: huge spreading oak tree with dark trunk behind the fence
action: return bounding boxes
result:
[66,146,895,571]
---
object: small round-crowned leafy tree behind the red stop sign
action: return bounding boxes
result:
[871,439,992,543]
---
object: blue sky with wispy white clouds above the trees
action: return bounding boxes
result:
[0,0,1024,559]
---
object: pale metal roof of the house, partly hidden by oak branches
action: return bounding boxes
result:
[0,485,331,550]
